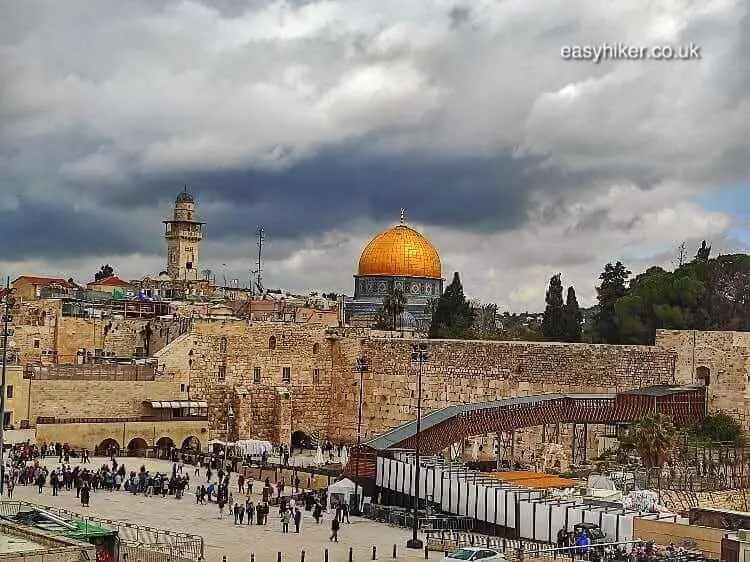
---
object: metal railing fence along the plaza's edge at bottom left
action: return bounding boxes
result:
[0,501,204,562]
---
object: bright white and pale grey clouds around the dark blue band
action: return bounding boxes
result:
[0,0,750,309]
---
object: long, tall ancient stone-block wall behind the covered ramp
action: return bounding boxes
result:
[151,322,750,460]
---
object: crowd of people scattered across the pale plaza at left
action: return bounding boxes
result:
[4,443,358,542]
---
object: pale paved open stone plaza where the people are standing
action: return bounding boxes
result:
[5,457,432,562]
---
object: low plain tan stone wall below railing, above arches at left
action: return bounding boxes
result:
[27,379,187,416]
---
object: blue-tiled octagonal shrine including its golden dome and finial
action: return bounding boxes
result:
[345,210,443,331]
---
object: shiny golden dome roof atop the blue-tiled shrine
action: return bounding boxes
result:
[359,224,442,279]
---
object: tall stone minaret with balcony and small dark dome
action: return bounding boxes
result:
[163,188,205,281]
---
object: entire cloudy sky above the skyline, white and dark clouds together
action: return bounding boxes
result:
[0,0,750,311]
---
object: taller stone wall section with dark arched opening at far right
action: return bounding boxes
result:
[656,330,750,431]
